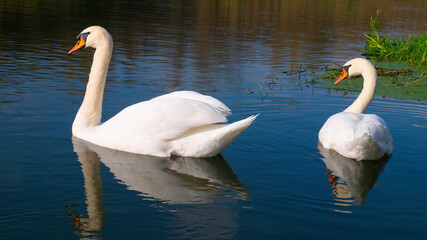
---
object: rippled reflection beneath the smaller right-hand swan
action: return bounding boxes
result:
[318,142,390,212]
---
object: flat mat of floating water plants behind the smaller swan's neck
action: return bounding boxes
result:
[241,62,427,102]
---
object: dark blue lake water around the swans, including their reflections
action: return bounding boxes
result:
[0,0,427,239]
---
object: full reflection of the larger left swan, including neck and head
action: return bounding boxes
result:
[69,137,249,237]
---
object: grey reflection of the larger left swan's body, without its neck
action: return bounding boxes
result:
[73,137,249,204]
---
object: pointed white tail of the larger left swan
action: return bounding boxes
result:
[171,114,259,157]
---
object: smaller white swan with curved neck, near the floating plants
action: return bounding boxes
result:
[319,58,393,160]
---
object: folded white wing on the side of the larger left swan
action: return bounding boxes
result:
[100,96,228,140]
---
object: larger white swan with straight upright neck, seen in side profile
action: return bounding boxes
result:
[69,26,257,157]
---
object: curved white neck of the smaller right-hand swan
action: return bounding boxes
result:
[344,67,377,113]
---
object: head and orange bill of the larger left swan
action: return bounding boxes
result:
[68,26,113,54]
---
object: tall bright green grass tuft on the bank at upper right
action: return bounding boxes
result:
[362,10,427,68]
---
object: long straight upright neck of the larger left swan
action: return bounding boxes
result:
[73,41,113,132]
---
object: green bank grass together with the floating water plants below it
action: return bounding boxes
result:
[242,10,427,102]
